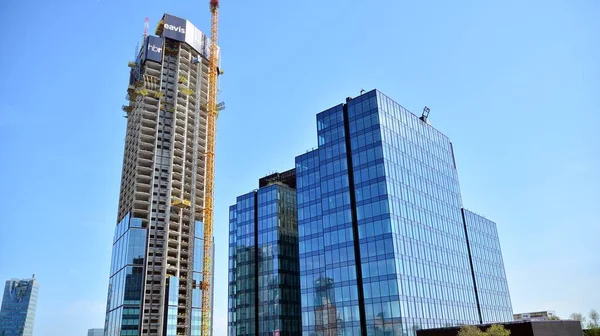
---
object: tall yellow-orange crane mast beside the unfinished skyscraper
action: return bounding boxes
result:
[201,0,220,336]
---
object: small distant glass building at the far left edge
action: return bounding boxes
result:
[0,275,39,336]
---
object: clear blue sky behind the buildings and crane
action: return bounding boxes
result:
[0,0,600,336]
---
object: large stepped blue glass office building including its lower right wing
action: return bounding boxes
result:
[296,90,512,336]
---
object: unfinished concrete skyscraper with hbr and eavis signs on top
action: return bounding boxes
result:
[104,14,214,336]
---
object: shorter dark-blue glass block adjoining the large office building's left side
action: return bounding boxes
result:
[228,170,301,336]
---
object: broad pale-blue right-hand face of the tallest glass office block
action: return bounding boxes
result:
[376,92,479,333]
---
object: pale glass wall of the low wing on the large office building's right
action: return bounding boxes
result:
[463,209,513,323]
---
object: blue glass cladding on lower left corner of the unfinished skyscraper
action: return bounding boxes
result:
[104,214,147,336]
